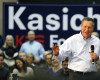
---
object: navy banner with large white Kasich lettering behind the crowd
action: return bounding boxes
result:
[3,3,100,50]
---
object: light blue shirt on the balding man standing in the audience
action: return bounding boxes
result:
[19,41,45,59]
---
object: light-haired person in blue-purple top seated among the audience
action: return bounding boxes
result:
[47,56,62,76]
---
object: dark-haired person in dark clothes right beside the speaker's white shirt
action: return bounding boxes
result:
[59,57,69,80]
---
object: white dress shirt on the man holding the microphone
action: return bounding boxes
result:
[57,32,100,72]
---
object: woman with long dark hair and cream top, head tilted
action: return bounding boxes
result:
[13,58,34,80]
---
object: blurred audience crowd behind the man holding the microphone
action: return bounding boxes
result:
[0,31,99,80]
